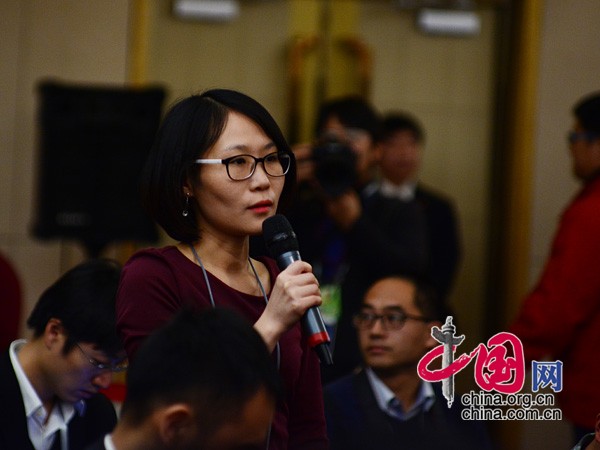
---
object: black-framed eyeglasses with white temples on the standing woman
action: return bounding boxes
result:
[194,152,292,181]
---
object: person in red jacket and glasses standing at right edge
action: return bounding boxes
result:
[511,92,600,442]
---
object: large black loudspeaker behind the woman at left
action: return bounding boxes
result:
[33,81,166,256]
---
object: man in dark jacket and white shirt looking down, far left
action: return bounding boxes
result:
[0,260,126,450]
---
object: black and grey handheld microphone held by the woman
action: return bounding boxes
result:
[263,214,333,365]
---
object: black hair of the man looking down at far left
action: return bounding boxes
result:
[27,258,123,357]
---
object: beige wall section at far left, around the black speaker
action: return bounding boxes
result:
[0,0,129,334]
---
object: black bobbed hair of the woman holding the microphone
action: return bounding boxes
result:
[141,89,296,243]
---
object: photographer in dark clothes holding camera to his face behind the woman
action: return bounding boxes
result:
[288,96,427,382]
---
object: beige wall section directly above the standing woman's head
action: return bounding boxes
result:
[146,0,290,122]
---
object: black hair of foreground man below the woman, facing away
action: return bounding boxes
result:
[122,308,282,433]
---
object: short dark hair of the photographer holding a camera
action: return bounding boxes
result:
[315,95,381,141]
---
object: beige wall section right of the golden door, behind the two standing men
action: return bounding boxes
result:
[361,2,496,345]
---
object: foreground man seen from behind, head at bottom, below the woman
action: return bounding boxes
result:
[87,309,281,450]
